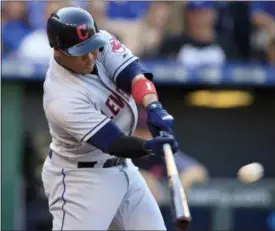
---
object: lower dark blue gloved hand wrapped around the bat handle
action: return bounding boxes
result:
[144,133,178,156]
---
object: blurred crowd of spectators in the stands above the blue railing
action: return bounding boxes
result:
[1,0,275,68]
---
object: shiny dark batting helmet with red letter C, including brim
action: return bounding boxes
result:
[47,7,108,56]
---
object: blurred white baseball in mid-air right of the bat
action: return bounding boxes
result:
[238,162,264,184]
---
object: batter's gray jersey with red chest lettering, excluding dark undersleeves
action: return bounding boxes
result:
[44,31,137,160]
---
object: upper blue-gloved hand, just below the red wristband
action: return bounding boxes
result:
[146,102,174,137]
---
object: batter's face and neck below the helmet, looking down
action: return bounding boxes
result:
[55,50,99,74]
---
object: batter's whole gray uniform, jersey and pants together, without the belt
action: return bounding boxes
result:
[42,31,166,230]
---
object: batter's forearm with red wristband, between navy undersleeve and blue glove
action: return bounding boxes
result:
[132,74,158,107]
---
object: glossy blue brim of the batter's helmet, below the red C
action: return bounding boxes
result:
[63,33,108,56]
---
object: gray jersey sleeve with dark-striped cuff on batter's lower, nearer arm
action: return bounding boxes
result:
[46,98,110,142]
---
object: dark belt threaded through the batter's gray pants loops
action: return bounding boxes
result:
[49,151,126,168]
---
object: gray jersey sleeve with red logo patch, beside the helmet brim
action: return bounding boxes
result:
[101,31,138,82]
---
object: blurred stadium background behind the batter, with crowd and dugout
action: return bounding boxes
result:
[1,0,275,231]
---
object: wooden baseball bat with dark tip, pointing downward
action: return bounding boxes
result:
[163,144,192,230]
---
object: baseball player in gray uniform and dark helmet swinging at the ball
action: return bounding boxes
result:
[41,7,178,230]
